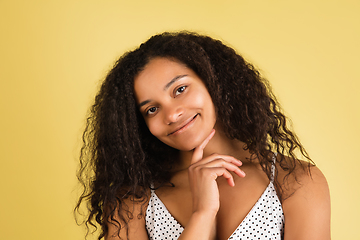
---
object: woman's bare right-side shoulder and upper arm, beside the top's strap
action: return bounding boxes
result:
[279,159,330,240]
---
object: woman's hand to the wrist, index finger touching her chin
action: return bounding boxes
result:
[189,130,245,216]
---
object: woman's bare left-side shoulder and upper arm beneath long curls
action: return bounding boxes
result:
[105,191,149,240]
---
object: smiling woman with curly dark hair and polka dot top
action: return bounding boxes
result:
[77,32,330,240]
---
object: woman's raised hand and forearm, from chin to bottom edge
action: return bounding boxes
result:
[179,130,245,240]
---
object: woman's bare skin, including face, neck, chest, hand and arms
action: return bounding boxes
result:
[106,58,330,240]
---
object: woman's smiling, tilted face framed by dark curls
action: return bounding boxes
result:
[134,58,216,151]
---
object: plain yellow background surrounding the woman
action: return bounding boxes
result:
[0,0,360,240]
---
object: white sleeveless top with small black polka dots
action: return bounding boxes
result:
[146,158,284,240]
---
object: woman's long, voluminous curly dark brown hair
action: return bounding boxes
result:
[75,32,312,239]
